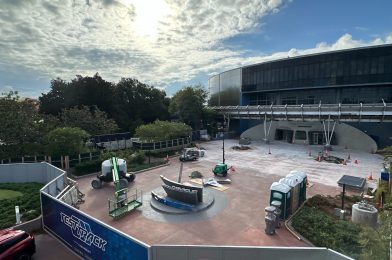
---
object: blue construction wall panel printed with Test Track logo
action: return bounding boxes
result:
[41,192,149,260]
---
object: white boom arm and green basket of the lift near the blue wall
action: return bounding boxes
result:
[108,157,143,219]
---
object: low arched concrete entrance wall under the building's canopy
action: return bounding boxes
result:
[241,121,377,152]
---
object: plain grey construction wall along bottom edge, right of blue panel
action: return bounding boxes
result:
[151,246,351,260]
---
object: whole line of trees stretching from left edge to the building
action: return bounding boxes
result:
[0,73,214,158]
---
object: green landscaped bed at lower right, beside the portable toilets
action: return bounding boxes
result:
[292,195,389,259]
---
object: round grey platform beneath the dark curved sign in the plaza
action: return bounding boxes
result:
[150,187,215,214]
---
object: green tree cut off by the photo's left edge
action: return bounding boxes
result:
[0,91,40,157]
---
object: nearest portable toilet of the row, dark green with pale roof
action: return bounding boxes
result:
[270,182,291,219]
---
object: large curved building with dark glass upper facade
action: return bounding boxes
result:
[209,44,392,151]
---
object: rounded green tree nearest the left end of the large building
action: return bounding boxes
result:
[169,85,207,129]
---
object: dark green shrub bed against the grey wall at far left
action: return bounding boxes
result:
[0,183,44,229]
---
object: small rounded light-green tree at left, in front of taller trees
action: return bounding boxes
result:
[45,127,89,156]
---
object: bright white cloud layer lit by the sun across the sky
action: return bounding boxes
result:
[0,0,392,94]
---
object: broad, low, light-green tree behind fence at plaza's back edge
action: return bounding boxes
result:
[135,120,192,141]
